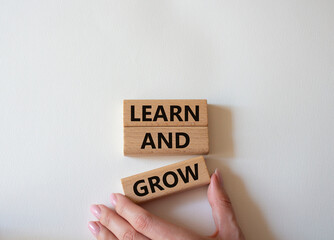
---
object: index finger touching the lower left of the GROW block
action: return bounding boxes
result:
[111,193,199,240]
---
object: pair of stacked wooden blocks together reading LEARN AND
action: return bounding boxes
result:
[123,100,209,155]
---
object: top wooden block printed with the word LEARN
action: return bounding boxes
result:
[123,100,208,127]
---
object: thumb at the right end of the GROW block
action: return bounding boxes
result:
[208,169,242,239]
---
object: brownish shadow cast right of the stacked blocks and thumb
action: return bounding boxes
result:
[206,105,275,240]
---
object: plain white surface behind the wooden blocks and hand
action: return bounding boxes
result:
[0,0,334,240]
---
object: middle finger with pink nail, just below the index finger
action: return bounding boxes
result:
[91,205,147,240]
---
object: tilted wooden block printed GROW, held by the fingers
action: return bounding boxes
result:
[121,156,210,203]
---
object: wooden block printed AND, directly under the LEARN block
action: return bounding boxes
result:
[124,127,209,155]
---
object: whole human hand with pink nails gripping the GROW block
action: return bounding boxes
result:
[88,169,245,240]
